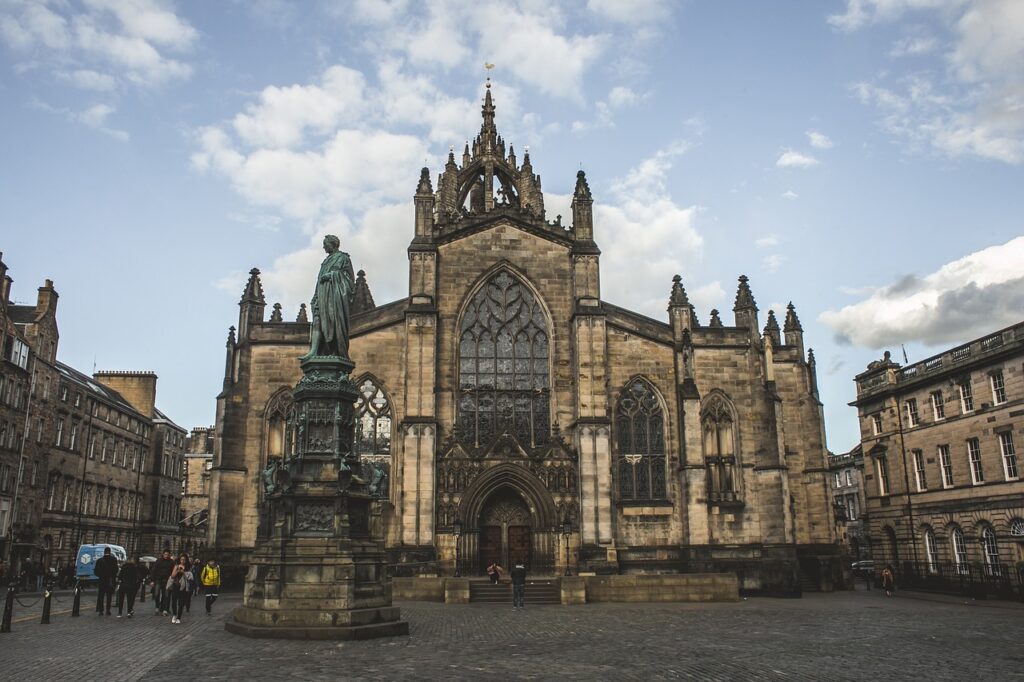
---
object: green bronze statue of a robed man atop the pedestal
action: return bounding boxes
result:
[301,235,355,359]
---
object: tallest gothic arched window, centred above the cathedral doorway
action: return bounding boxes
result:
[456,270,551,447]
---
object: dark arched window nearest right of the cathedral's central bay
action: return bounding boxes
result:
[615,379,666,500]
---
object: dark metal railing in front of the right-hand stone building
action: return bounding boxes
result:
[896,561,1024,601]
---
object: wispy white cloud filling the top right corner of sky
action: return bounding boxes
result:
[829,0,1024,164]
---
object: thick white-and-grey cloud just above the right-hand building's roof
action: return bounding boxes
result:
[820,237,1024,348]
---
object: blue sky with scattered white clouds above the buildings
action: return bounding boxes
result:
[0,0,1024,452]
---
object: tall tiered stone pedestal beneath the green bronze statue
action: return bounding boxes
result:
[224,357,409,639]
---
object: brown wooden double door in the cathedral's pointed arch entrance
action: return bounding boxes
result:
[478,487,534,571]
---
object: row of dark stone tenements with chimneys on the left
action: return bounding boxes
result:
[0,249,186,568]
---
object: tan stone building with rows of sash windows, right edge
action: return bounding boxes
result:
[851,323,1024,578]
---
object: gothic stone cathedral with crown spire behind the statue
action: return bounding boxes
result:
[210,85,837,590]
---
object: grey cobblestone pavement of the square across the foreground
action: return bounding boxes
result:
[0,590,1024,682]
